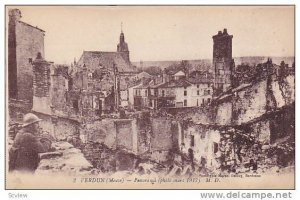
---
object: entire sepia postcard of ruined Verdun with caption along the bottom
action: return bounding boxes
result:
[5,5,295,189]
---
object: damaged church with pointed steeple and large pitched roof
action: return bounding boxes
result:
[72,29,137,111]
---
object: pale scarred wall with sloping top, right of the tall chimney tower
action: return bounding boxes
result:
[215,75,295,125]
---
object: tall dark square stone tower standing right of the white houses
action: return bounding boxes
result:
[212,29,234,95]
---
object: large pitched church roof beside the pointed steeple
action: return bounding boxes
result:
[78,51,136,72]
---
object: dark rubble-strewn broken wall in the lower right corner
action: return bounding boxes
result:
[219,102,295,172]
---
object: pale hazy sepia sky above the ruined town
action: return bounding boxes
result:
[8,6,294,63]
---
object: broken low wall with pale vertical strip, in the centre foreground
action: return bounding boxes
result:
[80,113,179,171]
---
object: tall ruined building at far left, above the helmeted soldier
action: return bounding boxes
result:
[8,9,45,106]
